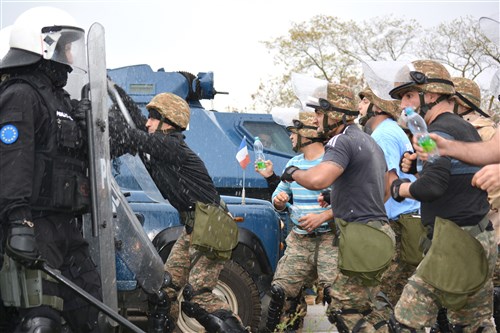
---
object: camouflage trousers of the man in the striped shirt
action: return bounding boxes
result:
[272,231,338,331]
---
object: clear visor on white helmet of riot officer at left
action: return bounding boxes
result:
[42,26,87,72]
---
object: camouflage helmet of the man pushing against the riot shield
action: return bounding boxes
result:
[146,93,190,130]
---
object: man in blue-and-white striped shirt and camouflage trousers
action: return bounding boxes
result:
[265,111,337,332]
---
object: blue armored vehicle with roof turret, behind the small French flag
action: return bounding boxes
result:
[108,65,295,199]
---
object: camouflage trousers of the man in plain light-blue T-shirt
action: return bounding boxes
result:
[380,221,417,306]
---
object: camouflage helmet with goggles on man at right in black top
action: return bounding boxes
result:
[389,60,455,99]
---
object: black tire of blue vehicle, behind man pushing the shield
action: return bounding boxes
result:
[177,260,261,333]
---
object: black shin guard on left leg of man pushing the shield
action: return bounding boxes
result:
[148,290,175,333]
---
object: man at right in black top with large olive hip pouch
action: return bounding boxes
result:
[390,60,497,332]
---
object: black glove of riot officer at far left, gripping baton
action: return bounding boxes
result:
[5,220,42,268]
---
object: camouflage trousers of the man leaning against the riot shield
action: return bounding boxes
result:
[164,229,231,321]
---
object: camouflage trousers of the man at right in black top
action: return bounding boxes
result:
[394,227,497,333]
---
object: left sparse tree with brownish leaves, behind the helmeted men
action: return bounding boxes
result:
[253,15,421,110]
